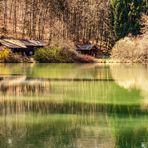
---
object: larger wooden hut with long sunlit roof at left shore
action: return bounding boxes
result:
[0,38,44,56]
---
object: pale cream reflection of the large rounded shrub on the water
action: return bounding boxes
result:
[111,65,148,109]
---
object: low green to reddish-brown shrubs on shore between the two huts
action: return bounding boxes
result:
[34,48,96,63]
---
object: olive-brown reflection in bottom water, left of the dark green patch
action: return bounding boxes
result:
[0,114,117,148]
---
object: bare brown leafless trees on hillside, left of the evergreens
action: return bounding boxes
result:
[0,0,112,48]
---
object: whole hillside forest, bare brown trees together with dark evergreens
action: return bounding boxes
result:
[0,0,148,49]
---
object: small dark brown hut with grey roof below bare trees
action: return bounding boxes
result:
[76,44,102,57]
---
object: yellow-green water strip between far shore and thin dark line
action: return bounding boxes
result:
[0,64,110,78]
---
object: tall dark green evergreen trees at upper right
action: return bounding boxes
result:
[110,0,145,39]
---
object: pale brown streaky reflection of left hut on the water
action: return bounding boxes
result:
[0,75,50,95]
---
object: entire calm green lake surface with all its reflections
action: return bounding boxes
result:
[0,64,148,148]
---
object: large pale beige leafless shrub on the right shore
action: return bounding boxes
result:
[112,16,148,63]
